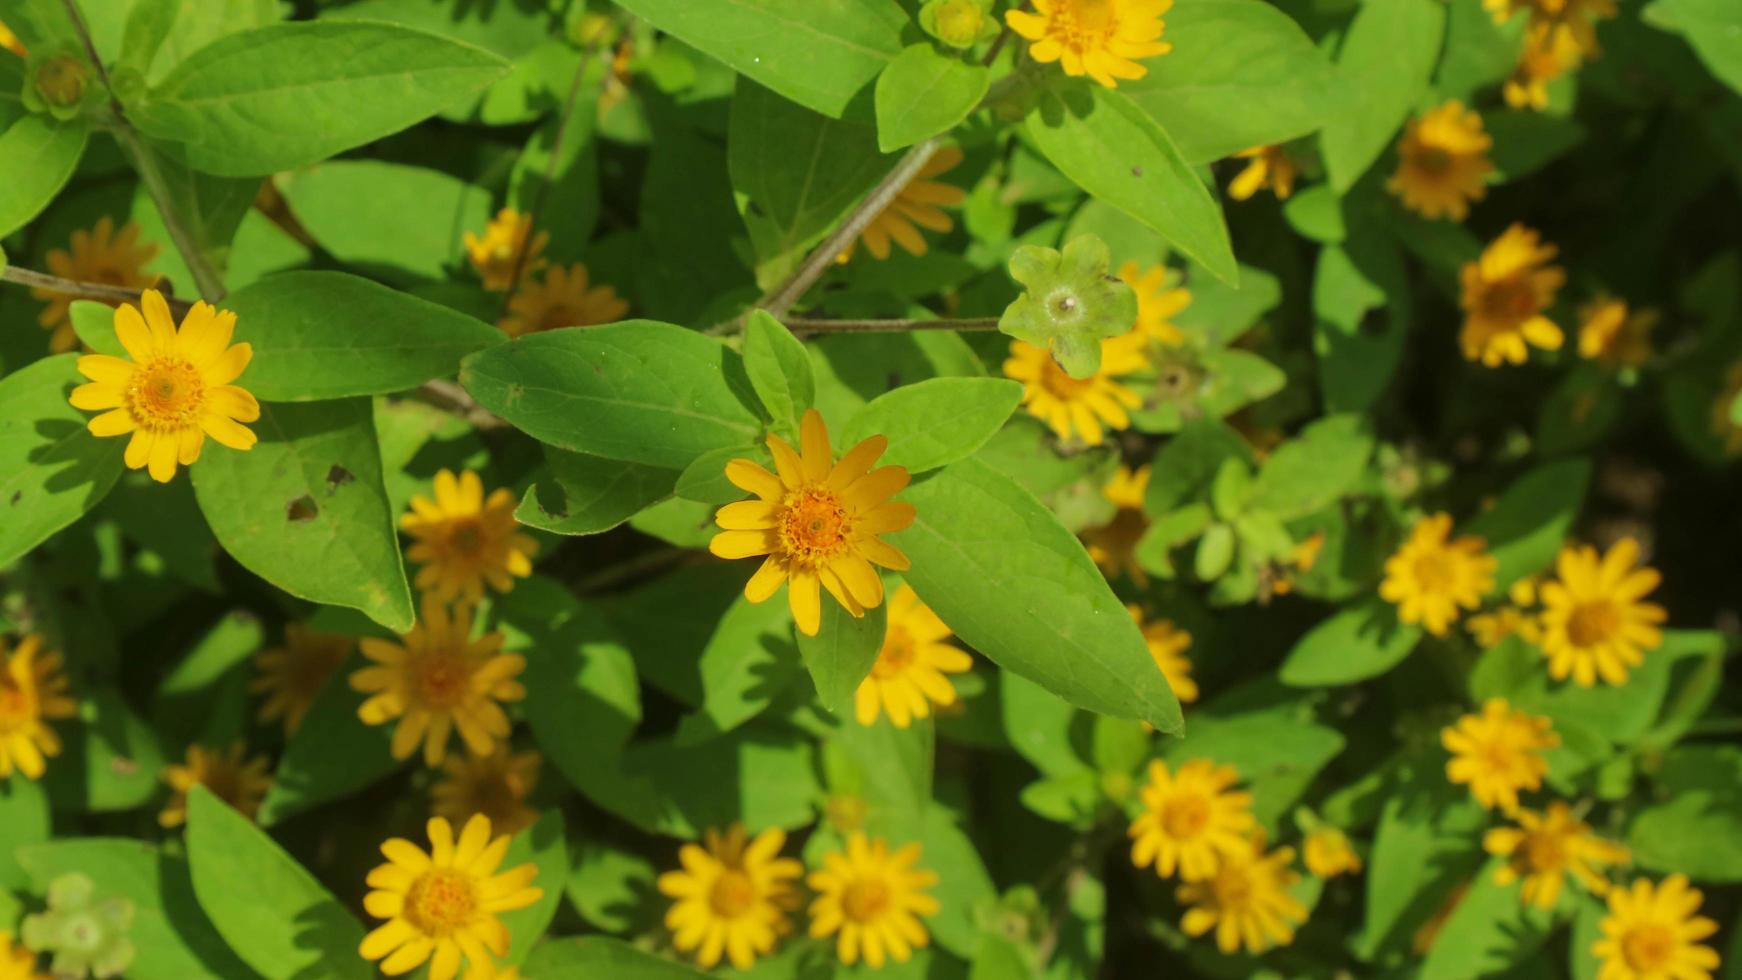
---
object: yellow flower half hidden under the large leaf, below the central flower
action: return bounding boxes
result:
[854,583,974,728]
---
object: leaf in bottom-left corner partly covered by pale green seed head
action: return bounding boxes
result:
[17,837,252,980]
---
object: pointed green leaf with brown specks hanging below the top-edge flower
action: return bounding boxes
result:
[1024,84,1240,282]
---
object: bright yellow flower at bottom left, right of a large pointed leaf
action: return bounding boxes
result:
[357,815,544,980]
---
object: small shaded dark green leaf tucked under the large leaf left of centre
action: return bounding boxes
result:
[514,446,678,534]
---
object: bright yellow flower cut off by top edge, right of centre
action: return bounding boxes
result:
[1003,0,1174,89]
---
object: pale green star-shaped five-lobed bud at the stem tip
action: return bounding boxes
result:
[998,235,1138,378]
